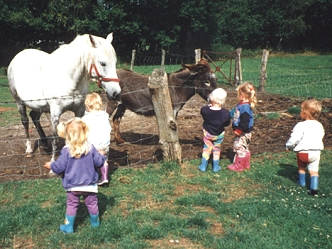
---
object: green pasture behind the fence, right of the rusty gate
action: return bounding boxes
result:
[241,55,332,98]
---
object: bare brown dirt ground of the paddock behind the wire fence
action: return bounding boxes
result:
[0,89,332,182]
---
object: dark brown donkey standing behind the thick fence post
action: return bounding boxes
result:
[106,61,217,144]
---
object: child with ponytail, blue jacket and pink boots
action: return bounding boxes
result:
[227,82,257,172]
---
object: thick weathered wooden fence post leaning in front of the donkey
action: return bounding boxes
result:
[148,69,182,163]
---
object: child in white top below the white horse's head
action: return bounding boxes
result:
[82,93,112,185]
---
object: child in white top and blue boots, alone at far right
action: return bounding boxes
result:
[286,99,325,195]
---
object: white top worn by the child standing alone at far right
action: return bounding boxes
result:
[286,120,325,152]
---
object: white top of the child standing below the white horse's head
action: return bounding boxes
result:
[82,111,112,150]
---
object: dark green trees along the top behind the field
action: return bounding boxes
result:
[0,0,332,66]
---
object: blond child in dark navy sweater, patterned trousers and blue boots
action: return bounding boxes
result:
[198,88,230,172]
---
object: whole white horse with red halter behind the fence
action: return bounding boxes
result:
[8,33,121,161]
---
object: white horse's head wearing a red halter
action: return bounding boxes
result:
[89,33,121,99]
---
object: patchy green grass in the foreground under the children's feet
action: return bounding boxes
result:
[0,151,332,249]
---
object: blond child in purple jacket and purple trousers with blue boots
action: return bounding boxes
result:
[44,118,106,233]
